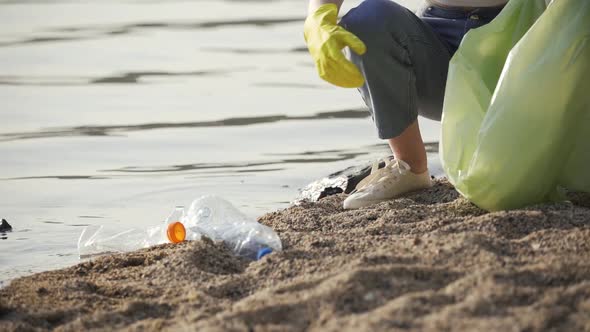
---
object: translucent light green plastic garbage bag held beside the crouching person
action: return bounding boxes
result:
[440,0,590,211]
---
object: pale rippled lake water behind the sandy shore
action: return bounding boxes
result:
[0,0,439,284]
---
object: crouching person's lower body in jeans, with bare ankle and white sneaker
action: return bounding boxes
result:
[340,0,501,209]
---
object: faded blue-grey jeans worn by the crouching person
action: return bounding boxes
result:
[340,0,501,139]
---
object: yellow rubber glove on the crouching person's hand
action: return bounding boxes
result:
[303,3,367,88]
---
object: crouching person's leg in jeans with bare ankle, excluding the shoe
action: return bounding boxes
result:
[340,0,451,173]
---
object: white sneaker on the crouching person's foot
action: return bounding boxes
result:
[344,158,432,209]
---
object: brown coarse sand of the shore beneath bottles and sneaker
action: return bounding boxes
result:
[0,180,590,331]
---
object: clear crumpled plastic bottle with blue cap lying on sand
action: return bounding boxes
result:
[181,195,282,260]
